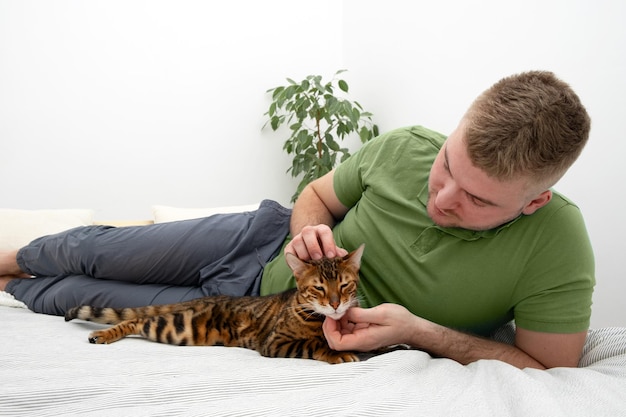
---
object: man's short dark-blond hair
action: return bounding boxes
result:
[463,71,591,188]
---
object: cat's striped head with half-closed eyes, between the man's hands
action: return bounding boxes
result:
[286,244,365,320]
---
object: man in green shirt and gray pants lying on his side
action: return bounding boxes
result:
[0,72,595,368]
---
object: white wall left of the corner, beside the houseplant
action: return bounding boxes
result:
[0,0,341,220]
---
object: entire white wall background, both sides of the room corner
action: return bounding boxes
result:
[0,0,626,327]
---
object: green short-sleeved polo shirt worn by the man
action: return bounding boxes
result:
[261,127,595,335]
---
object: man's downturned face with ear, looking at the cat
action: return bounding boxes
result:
[428,128,552,230]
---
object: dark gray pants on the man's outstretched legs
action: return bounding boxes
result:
[6,200,291,315]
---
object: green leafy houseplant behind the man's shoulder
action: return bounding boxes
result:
[265,70,378,202]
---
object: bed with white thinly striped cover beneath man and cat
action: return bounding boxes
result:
[0,208,626,417]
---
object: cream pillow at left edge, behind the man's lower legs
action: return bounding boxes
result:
[0,209,94,250]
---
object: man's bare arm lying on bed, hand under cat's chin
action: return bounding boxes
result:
[324,304,587,369]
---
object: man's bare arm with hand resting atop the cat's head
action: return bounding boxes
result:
[285,171,348,260]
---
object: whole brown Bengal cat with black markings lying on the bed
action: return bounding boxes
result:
[65,245,365,363]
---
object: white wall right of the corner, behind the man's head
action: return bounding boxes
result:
[343,0,626,327]
